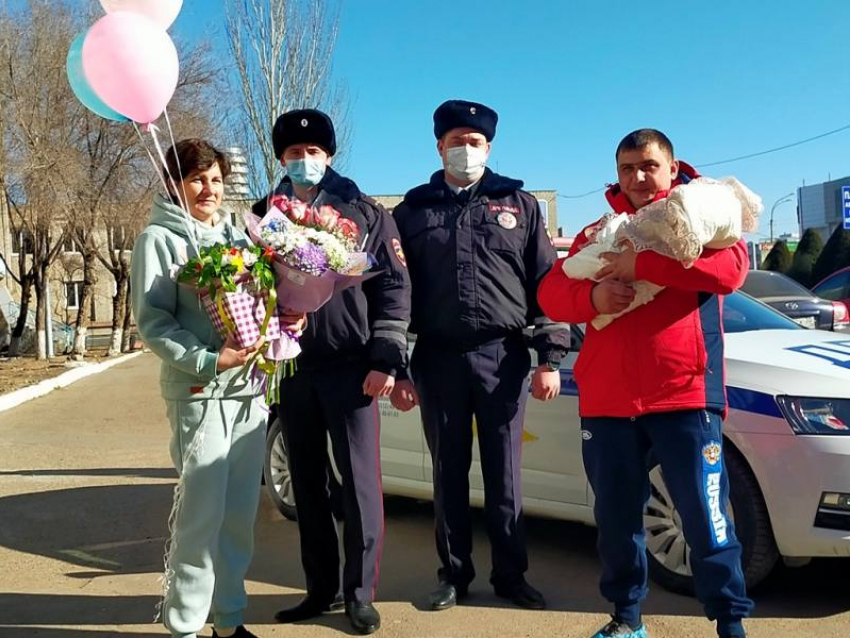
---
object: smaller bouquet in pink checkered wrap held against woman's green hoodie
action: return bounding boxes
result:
[176,244,301,403]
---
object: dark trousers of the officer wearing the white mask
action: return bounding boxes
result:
[411,335,530,587]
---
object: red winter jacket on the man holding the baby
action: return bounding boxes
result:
[537,162,749,417]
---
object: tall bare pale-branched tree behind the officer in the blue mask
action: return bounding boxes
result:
[226,0,349,196]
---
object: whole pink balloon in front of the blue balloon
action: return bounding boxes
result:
[83,11,180,124]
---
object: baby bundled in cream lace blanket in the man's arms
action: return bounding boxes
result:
[563,177,764,330]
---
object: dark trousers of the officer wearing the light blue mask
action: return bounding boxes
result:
[279,361,384,602]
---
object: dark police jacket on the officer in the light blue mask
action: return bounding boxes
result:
[252,167,410,375]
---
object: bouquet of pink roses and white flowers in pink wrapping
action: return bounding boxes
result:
[246,195,377,312]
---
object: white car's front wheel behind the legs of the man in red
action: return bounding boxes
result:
[644,447,779,596]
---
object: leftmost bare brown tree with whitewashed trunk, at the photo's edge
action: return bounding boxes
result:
[0,1,82,358]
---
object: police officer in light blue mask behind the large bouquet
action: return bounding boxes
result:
[254,109,410,634]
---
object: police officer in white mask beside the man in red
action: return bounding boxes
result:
[392,100,569,610]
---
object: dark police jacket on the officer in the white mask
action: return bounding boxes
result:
[393,169,569,363]
